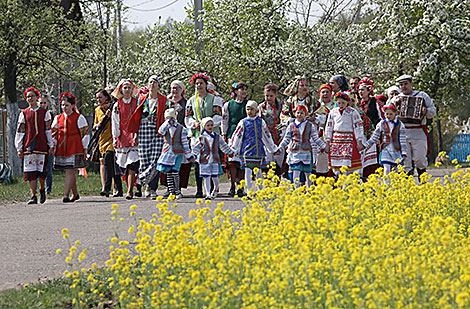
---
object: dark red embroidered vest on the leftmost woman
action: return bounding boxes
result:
[22,107,49,154]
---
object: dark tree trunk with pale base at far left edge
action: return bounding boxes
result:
[3,53,22,176]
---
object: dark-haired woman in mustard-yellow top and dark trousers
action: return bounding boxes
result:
[93,88,123,197]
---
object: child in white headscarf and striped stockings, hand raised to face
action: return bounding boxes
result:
[157,108,193,199]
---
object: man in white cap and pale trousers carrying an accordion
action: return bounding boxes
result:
[395,75,436,177]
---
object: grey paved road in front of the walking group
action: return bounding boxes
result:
[0,170,462,290]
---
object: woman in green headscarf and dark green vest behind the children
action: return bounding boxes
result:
[222,82,248,196]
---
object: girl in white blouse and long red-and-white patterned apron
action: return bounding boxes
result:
[325,92,364,175]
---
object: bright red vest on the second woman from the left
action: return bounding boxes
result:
[55,112,83,157]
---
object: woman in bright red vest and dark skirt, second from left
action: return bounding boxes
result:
[52,93,90,203]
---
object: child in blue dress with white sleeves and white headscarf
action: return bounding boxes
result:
[232,101,280,196]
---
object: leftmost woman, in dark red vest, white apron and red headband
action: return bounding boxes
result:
[15,87,54,204]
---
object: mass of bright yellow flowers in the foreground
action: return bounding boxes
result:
[63,170,470,308]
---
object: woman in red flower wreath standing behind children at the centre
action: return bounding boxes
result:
[184,73,224,197]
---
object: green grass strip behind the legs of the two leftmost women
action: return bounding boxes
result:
[0,171,101,204]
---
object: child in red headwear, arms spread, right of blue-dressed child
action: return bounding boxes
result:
[279,105,329,188]
